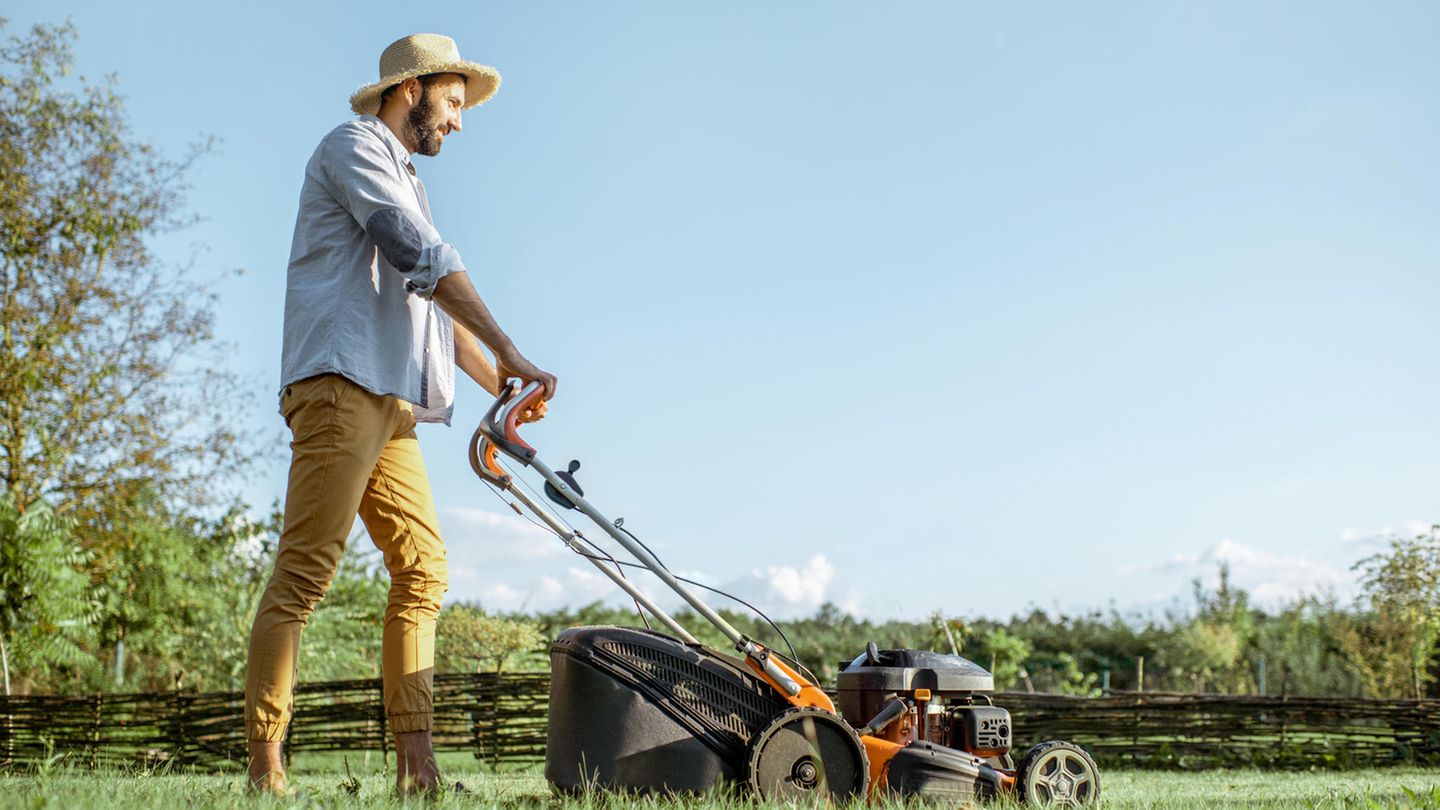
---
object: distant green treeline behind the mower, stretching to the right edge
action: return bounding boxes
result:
[524,532,1440,698]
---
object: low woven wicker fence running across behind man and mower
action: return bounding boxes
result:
[0,673,1440,768]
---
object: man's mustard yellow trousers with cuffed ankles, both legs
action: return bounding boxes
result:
[245,375,449,742]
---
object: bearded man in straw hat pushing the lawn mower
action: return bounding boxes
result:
[245,35,556,793]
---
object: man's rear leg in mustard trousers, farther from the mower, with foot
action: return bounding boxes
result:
[245,375,395,791]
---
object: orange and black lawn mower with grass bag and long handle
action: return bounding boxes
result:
[469,383,1100,804]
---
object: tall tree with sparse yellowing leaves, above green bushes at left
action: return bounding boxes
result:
[0,20,253,524]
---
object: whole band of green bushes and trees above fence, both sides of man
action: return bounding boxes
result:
[0,478,1440,699]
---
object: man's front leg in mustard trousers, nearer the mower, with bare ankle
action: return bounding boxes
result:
[360,409,449,791]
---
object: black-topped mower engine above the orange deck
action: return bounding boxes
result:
[837,643,1014,770]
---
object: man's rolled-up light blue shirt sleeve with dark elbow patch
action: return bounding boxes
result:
[321,127,465,298]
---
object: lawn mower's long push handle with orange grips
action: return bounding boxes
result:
[469,382,801,696]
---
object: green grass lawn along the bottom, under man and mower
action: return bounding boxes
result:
[8,755,1440,810]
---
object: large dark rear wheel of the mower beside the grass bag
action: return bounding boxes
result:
[747,708,870,801]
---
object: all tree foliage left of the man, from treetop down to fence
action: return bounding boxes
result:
[0,19,275,690]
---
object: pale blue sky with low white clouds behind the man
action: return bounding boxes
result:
[6,0,1440,618]
